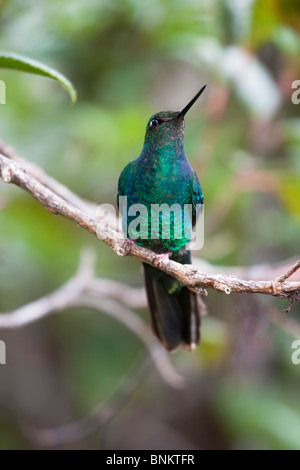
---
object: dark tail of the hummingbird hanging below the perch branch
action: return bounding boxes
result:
[144,251,206,351]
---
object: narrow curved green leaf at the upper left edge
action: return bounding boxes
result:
[0,51,77,103]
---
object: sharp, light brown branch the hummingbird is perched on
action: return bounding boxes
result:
[0,148,300,301]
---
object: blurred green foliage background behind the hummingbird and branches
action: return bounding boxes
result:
[0,0,300,449]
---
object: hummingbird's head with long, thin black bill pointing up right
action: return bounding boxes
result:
[145,85,206,147]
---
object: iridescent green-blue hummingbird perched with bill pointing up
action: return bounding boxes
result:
[117,85,206,351]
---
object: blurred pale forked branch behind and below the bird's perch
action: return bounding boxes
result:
[0,250,184,388]
